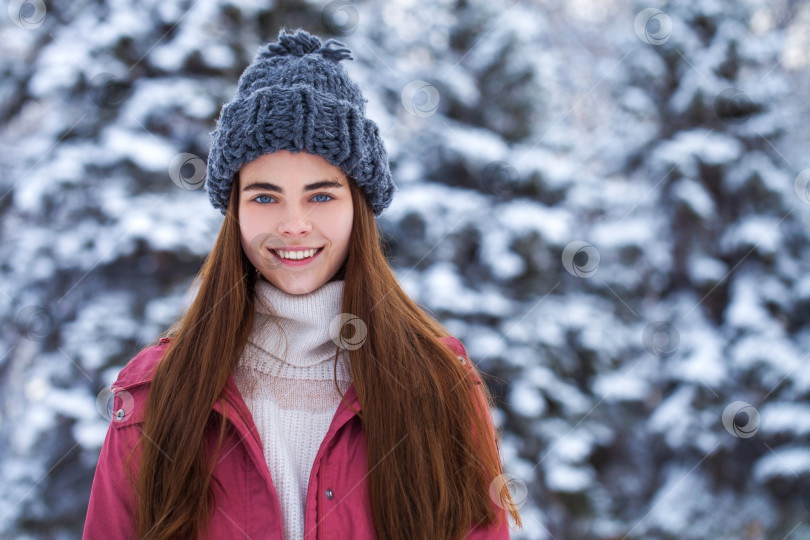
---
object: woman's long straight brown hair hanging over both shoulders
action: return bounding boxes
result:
[129,172,522,540]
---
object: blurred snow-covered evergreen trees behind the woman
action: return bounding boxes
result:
[0,0,810,540]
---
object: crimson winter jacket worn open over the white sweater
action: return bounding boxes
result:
[83,337,509,540]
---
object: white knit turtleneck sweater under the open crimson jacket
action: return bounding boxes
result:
[233,277,352,540]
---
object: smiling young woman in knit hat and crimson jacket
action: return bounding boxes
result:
[84,29,521,540]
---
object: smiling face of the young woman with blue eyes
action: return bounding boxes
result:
[238,150,354,294]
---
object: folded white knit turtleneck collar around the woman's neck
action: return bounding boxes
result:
[248,277,345,367]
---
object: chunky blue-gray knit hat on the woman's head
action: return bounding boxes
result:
[206,28,397,216]
